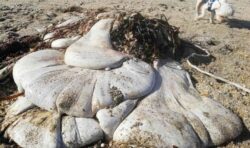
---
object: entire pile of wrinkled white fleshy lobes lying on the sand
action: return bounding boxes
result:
[2,19,242,147]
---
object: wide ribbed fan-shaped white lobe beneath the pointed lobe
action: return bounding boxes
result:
[13,50,155,117]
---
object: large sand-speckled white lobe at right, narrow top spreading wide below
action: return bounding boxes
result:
[114,61,242,147]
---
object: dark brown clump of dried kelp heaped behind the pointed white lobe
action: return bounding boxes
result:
[111,13,180,63]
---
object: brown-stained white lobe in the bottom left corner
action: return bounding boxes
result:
[6,109,61,148]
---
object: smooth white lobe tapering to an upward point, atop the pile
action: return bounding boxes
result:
[65,19,126,69]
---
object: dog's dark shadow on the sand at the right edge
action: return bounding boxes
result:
[227,19,250,30]
